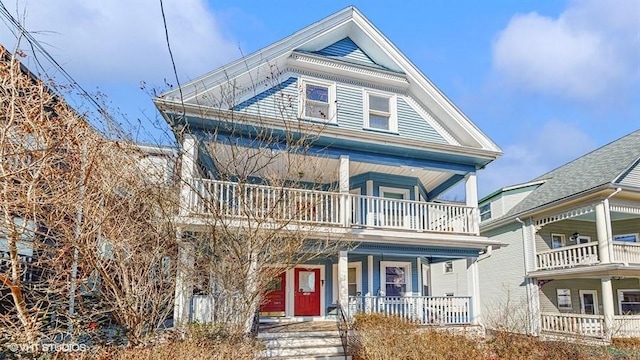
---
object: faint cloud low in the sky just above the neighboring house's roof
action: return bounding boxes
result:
[478,121,596,196]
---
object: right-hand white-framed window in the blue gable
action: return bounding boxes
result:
[364,91,398,132]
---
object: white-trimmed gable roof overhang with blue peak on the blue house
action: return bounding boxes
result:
[154,7,501,159]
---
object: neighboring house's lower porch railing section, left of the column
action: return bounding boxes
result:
[540,313,604,337]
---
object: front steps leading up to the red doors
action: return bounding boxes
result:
[258,324,351,360]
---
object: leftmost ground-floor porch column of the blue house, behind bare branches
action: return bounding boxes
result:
[173,229,194,327]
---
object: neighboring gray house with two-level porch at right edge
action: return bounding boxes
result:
[478,130,640,339]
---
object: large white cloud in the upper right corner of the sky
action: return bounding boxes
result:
[493,0,640,100]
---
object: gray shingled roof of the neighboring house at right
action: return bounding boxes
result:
[503,129,640,218]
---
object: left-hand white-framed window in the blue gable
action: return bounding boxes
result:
[300,80,336,122]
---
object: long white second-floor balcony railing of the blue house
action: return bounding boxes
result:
[188,179,479,235]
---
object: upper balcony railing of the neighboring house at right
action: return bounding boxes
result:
[536,242,640,270]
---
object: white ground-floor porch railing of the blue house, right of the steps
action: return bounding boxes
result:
[347,296,471,325]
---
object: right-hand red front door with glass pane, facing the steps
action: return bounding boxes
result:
[293,268,320,316]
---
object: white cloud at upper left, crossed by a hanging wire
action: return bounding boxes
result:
[0,0,240,85]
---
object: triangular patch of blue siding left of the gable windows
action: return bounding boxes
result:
[234,77,298,119]
